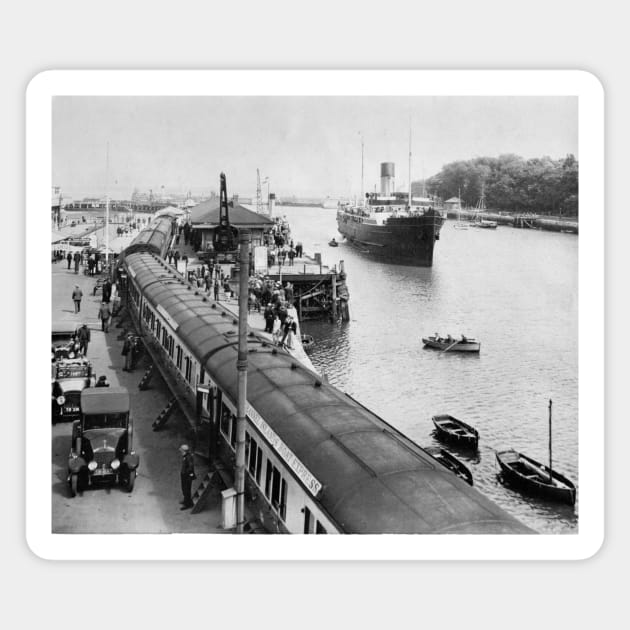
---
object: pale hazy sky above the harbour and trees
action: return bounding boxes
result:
[52,96,579,199]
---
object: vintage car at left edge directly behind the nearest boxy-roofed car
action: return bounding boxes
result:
[52,358,96,424]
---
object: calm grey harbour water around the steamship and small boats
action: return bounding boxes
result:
[286,206,579,534]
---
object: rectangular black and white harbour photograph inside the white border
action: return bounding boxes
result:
[32,72,601,557]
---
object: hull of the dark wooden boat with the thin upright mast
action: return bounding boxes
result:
[496,449,576,505]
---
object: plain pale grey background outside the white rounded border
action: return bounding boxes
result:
[7,0,630,628]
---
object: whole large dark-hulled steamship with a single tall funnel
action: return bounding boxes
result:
[337,162,444,267]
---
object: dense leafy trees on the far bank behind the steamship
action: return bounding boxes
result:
[412,154,578,217]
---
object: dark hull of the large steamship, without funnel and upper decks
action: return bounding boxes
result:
[337,211,443,267]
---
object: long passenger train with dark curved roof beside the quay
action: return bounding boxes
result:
[119,211,535,534]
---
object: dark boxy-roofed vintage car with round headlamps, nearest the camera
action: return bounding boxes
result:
[68,387,140,497]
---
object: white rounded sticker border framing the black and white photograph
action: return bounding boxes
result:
[25,70,604,560]
